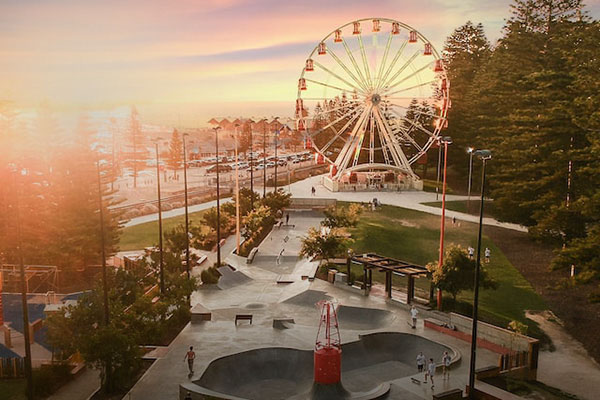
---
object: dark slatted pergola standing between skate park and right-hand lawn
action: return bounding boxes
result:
[351,253,432,304]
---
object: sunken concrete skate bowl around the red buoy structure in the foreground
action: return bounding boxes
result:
[180,332,458,400]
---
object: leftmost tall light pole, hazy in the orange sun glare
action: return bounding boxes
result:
[14,166,33,400]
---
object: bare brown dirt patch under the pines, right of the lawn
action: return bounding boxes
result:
[484,226,600,361]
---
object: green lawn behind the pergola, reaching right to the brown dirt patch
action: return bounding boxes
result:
[338,203,547,328]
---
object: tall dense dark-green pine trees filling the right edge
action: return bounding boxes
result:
[444,0,600,290]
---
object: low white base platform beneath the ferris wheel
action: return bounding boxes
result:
[323,176,423,192]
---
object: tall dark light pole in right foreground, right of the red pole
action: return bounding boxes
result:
[469,150,492,399]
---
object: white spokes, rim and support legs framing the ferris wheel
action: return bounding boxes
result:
[296,17,450,179]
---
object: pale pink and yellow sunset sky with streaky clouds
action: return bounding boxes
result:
[0,0,600,127]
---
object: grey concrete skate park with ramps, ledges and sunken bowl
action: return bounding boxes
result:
[119,206,532,400]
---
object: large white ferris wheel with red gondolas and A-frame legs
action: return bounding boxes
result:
[296,18,450,179]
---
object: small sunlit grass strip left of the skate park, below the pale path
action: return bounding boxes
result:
[119,210,211,251]
